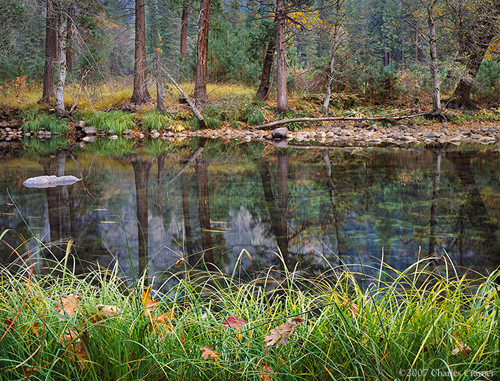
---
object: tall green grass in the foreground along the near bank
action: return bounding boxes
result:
[0,243,500,380]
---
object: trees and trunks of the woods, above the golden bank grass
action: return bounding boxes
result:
[0,0,500,115]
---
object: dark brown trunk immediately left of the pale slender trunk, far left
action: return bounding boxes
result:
[40,0,57,103]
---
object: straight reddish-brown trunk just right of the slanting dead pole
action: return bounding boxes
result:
[194,0,210,105]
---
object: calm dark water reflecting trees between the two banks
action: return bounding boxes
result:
[0,140,500,276]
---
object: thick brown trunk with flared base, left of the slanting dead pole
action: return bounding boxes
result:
[130,0,151,104]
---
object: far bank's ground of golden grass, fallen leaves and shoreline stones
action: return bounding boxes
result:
[0,80,500,146]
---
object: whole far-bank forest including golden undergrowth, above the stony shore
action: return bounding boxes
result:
[0,0,500,127]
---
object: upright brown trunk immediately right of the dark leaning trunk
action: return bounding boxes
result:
[276,0,289,115]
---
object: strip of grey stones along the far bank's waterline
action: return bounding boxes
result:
[0,122,500,147]
